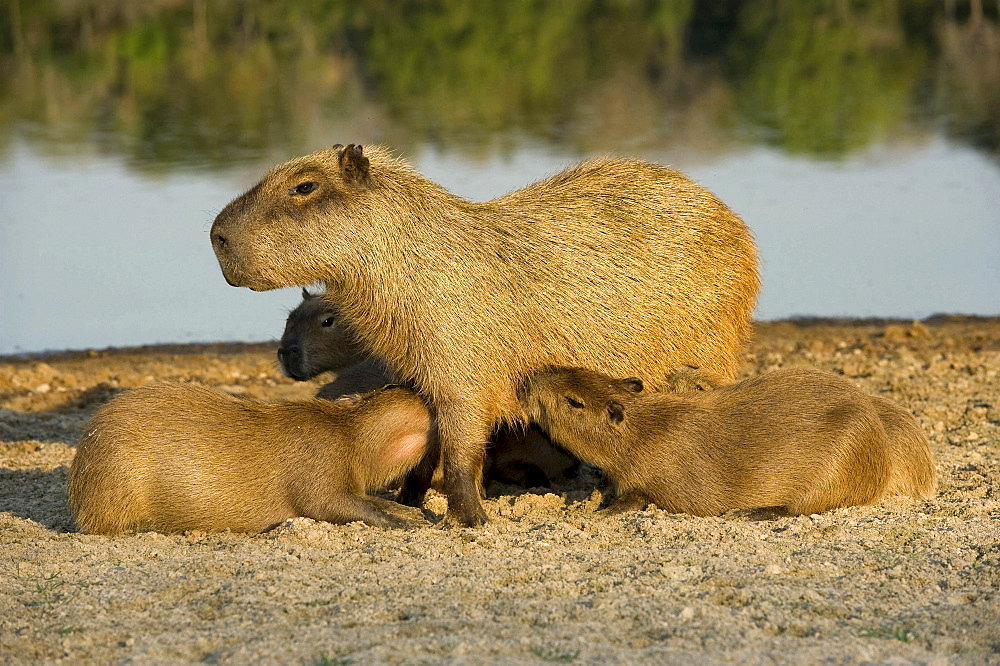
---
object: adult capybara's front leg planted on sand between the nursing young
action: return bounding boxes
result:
[437,411,493,527]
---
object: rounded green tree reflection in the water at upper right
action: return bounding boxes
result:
[730,0,927,157]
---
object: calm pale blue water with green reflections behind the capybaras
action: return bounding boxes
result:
[0,0,1000,354]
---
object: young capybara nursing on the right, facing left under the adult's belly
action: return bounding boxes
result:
[519,368,935,516]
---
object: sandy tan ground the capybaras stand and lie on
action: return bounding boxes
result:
[0,318,1000,664]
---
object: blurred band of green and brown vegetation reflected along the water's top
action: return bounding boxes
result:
[0,0,1000,170]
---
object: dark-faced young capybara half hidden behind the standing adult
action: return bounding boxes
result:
[278,289,579,488]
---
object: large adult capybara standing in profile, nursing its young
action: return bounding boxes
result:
[211,144,759,525]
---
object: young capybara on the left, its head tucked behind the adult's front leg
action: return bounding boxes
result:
[69,382,431,535]
